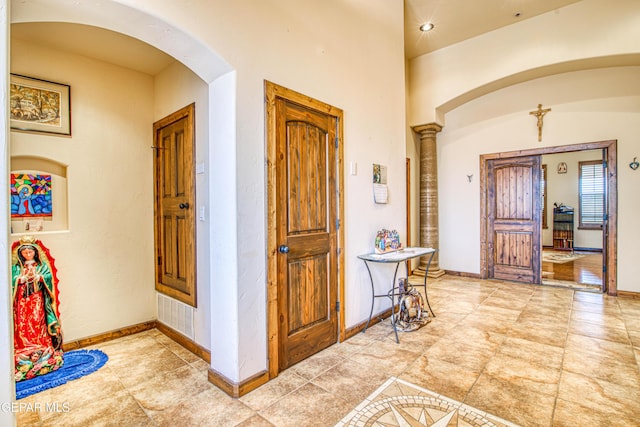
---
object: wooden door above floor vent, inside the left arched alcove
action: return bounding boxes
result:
[153,104,196,307]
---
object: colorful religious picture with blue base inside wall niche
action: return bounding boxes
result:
[11,174,53,218]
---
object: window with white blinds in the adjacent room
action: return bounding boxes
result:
[578,160,604,229]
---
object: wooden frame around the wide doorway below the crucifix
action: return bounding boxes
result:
[480,139,618,296]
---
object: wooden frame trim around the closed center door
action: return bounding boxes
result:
[264,80,346,378]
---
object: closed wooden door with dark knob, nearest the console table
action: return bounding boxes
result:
[276,99,338,370]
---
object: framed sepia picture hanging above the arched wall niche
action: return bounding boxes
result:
[9,74,71,136]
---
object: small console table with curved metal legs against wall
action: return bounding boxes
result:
[358,247,438,343]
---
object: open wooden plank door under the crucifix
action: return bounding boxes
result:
[487,156,542,283]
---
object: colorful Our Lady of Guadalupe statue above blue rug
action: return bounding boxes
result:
[11,236,64,381]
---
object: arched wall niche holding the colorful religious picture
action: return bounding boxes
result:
[10,156,69,235]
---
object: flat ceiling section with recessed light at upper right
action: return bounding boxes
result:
[404,0,580,59]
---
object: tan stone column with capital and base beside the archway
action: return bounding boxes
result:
[413,123,445,277]
